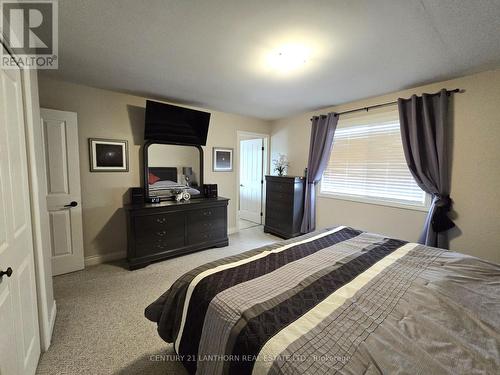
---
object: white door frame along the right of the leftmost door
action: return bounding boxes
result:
[0,36,56,352]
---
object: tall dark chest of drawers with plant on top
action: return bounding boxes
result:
[264,176,305,238]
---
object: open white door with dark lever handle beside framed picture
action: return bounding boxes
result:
[40,108,84,275]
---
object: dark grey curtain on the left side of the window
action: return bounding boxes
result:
[301,112,339,233]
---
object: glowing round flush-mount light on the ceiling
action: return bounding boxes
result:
[266,44,310,75]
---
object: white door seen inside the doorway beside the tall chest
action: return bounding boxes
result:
[240,139,264,224]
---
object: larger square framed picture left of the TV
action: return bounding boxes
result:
[89,138,128,172]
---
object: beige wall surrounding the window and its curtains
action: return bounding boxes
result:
[271,70,500,263]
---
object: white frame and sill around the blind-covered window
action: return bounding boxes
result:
[317,110,432,212]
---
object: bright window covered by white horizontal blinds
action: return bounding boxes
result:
[320,110,428,209]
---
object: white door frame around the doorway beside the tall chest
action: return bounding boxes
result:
[234,130,270,232]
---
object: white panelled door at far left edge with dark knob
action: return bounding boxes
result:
[0,61,40,375]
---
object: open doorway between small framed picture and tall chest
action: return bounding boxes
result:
[237,132,269,230]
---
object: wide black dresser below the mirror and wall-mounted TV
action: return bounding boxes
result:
[125,197,229,269]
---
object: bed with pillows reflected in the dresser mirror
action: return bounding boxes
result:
[148,167,200,198]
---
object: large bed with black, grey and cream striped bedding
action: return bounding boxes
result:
[145,227,500,375]
